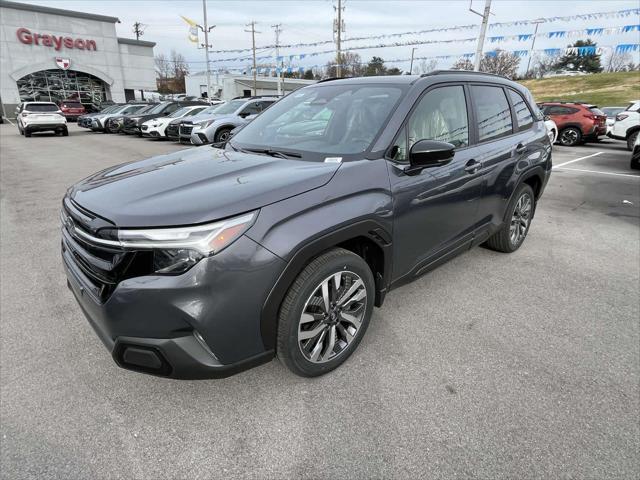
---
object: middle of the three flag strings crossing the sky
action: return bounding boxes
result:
[210,24,640,63]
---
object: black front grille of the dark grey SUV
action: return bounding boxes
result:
[61,204,153,303]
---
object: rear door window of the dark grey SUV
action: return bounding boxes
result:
[471,85,513,142]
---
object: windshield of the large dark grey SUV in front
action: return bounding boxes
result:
[232,84,402,154]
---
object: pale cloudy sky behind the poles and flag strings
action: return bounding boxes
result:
[17,0,640,72]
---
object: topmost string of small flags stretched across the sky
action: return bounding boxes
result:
[202,8,640,53]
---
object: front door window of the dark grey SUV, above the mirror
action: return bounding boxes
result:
[404,85,469,148]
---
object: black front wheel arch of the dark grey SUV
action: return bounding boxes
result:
[260,220,392,350]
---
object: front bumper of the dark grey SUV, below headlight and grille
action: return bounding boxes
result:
[62,232,285,379]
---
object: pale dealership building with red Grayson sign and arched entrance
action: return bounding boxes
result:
[0,0,156,116]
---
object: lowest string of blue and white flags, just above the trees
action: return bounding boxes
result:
[211,43,640,75]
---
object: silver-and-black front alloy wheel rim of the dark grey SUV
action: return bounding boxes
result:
[298,270,367,363]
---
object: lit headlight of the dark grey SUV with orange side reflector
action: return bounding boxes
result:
[113,212,257,273]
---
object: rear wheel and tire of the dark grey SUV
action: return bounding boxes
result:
[485,183,536,253]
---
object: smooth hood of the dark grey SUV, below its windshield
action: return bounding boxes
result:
[68,147,340,227]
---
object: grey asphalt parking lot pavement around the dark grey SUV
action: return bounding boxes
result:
[0,125,640,479]
